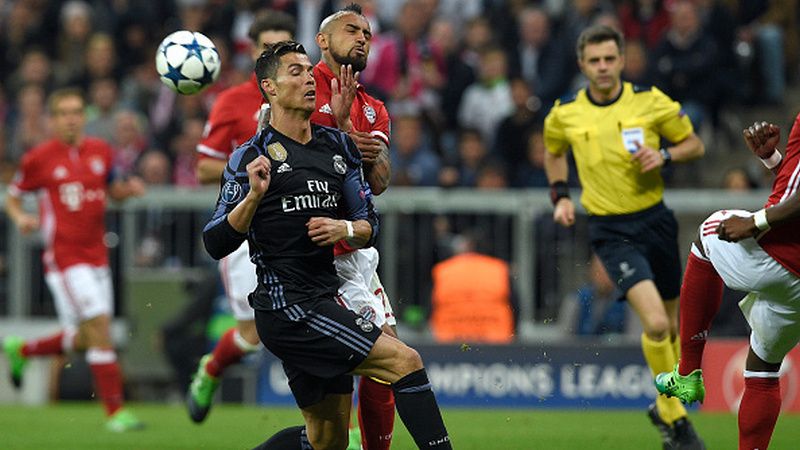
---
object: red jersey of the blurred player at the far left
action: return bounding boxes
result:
[9,137,113,271]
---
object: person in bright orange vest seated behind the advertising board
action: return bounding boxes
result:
[431,232,514,344]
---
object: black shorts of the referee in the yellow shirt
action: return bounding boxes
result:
[589,203,681,300]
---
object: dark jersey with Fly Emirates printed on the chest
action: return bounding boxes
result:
[203,125,378,310]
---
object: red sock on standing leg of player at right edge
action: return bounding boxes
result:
[739,378,781,450]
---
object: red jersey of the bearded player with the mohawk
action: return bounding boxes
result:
[311,61,390,255]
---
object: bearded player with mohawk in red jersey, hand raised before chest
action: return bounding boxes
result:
[311,5,397,450]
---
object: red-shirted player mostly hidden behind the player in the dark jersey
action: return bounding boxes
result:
[187,11,295,423]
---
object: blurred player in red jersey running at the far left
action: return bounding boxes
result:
[3,89,144,431]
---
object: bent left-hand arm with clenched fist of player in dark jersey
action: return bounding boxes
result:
[203,147,264,259]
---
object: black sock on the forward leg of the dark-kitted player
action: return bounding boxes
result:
[392,369,453,449]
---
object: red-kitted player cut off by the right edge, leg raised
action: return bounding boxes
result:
[656,115,800,450]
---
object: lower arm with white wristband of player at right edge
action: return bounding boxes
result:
[717,192,800,242]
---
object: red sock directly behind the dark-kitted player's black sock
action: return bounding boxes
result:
[358,377,394,450]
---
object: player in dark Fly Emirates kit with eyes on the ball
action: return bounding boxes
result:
[203,41,451,449]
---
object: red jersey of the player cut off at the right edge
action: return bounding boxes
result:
[758,111,800,277]
